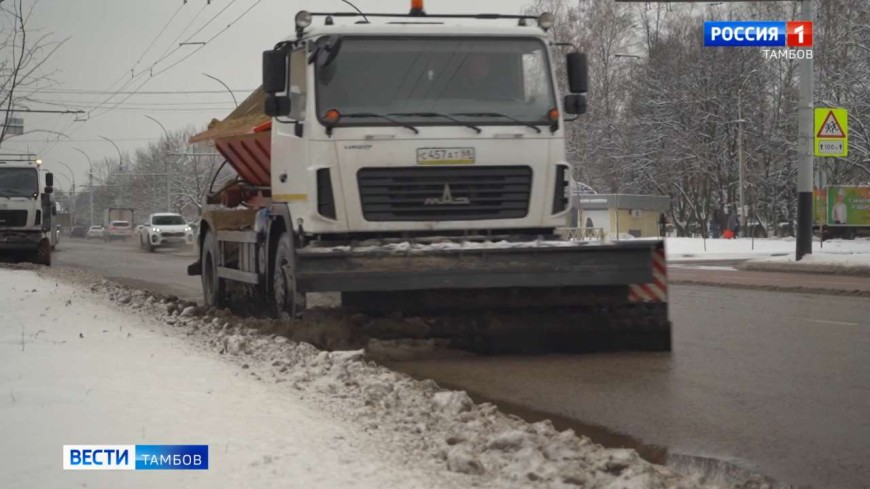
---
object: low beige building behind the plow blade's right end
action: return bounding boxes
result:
[570,194,671,239]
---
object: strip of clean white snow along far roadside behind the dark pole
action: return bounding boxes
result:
[666,234,870,261]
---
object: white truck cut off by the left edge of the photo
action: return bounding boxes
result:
[0,160,56,265]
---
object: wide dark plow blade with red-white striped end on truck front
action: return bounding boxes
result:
[297,240,671,353]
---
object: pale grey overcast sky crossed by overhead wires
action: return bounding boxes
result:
[0,0,530,189]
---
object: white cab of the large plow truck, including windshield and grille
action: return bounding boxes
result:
[264,13,585,240]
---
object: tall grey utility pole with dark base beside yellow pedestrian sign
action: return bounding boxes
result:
[795,0,815,260]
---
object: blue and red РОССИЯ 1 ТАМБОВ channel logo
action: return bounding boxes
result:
[704,21,813,59]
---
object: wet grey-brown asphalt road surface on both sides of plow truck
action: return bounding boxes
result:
[55,239,870,489]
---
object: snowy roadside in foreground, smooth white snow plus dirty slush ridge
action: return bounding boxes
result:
[0,268,716,489]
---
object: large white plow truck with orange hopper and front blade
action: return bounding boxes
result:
[188,1,671,351]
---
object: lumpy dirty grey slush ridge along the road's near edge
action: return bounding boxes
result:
[6,271,736,489]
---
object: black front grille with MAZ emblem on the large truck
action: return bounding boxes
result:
[357,166,532,221]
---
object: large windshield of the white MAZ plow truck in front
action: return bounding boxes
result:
[317,38,556,125]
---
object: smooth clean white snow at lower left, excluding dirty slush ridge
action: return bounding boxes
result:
[0,269,457,489]
